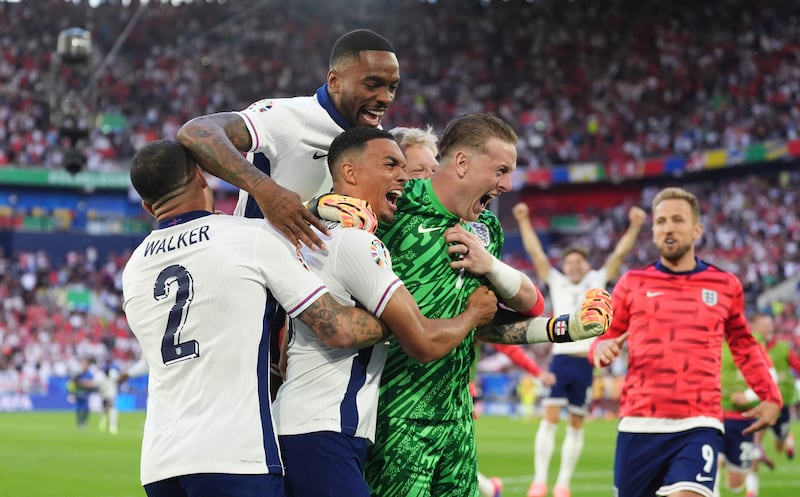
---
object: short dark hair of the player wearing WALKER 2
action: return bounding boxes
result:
[131,140,197,205]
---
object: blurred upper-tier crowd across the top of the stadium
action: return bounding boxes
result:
[0,0,800,169]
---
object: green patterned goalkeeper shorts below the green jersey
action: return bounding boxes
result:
[365,417,478,497]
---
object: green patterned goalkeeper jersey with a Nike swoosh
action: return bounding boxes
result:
[377,179,503,421]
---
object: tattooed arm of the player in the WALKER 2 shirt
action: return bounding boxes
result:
[298,293,389,349]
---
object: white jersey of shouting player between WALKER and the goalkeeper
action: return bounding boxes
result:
[274,226,403,441]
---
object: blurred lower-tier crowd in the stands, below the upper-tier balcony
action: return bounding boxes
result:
[0,171,800,391]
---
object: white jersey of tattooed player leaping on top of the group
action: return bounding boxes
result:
[234,85,350,217]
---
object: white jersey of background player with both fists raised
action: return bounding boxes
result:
[547,267,608,355]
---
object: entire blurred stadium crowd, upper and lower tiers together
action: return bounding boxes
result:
[0,0,800,414]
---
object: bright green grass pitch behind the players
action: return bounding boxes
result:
[0,412,800,497]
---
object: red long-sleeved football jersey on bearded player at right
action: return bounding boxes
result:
[589,259,781,419]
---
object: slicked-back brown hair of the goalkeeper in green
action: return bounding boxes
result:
[439,112,519,157]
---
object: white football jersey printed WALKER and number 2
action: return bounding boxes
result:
[122,212,327,484]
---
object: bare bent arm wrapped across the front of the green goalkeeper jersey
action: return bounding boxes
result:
[381,286,497,363]
